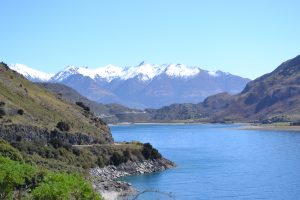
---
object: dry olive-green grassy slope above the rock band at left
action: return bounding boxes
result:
[0,63,107,135]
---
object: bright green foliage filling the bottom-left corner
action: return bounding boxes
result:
[0,156,102,200]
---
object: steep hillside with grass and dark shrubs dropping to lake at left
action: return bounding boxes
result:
[0,63,174,199]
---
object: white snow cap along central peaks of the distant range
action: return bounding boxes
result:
[51,62,225,82]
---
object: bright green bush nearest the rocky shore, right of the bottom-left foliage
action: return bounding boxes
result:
[32,173,101,200]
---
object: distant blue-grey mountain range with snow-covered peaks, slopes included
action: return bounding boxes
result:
[10,62,250,109]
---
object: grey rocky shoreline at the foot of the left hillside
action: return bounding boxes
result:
[90,158,175,200]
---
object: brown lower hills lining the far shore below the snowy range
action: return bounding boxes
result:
[6,55,300,123]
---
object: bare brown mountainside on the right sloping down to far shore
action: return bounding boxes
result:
[147,56,300,122]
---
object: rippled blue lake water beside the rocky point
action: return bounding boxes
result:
[111,125,300,200]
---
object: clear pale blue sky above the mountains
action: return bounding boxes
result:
[0,0,300,78]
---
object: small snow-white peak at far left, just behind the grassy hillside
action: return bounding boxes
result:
[9,63,54,82]
